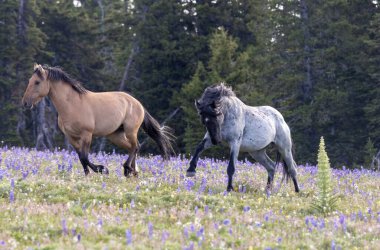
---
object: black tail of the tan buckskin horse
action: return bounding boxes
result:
[142,110,175,160]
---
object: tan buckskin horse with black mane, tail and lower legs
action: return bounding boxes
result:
[22,64,174,177]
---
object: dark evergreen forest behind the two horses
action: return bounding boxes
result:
[0,0,380,167]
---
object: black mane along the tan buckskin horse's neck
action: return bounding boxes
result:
[34,65,87,94]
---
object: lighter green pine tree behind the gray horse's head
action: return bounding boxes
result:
[176,29,248,156]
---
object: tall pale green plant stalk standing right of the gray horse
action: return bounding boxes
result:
[313,136,337,215]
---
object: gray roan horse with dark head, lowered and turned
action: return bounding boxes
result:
[187,83,299,194]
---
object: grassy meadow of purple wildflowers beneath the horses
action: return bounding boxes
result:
[0,147,380,249]
